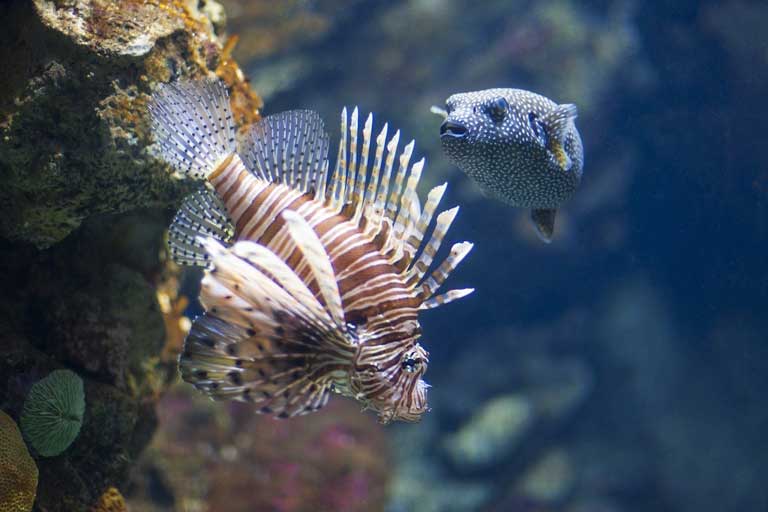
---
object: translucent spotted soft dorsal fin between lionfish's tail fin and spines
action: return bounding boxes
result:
[239,110,328,193]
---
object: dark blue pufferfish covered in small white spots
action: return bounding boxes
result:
[432,89,584,243]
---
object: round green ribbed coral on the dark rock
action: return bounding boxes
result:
[21,370,85,457]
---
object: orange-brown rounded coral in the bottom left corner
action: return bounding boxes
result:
[0,411,37,512]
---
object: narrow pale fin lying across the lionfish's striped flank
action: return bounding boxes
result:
[283,210,346,330]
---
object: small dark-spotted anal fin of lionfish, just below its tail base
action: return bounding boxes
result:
[168,187,234,267]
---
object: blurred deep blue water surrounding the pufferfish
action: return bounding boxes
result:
[249,1,768,512]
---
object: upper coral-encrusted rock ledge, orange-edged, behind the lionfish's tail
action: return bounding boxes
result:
[0,0,261,248]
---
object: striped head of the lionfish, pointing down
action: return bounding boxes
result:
[352,336,430,424]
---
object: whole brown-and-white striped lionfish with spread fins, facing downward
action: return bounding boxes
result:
[149,80,473,423]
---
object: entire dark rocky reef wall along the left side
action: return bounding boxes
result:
[0,0,261,511]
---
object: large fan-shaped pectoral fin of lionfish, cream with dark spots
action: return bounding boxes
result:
[180,239,354,418]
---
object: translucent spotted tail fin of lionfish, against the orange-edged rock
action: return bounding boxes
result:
[148,79,236,179]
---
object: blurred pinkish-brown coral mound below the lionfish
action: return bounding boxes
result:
[128,385,389,512]
